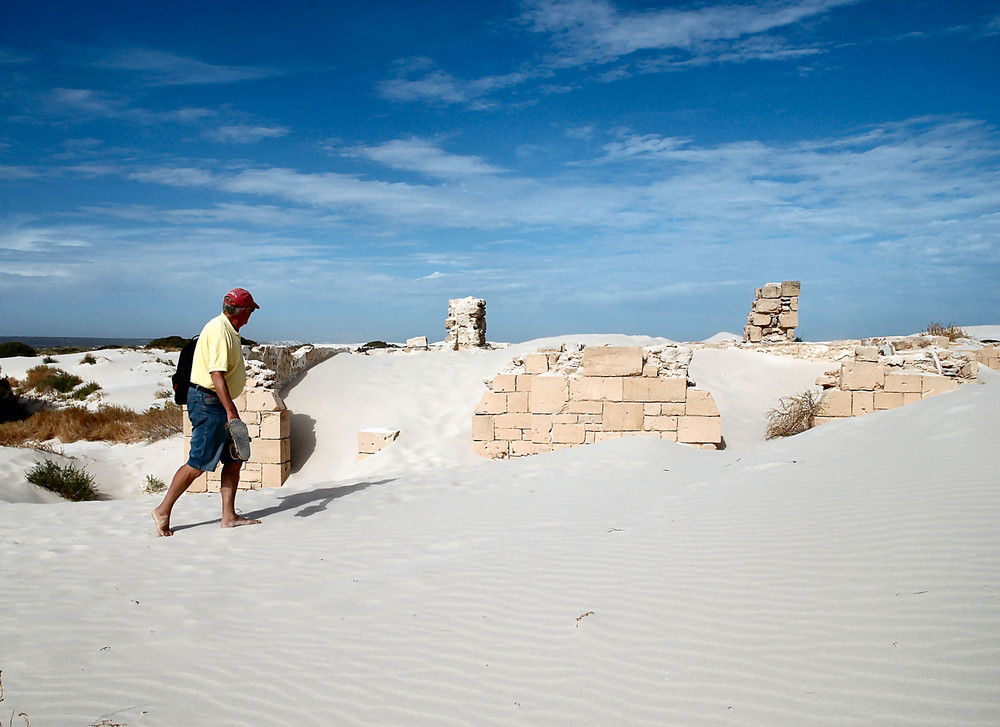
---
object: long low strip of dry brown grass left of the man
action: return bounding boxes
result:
[0,404,183,447]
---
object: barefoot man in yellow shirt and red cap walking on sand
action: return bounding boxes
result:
[153,288,260,535]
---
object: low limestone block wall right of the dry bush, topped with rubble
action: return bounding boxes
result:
[816,346,978,424]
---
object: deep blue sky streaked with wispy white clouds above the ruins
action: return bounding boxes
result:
[0,0,1000,341]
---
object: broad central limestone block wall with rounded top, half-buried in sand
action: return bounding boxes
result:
[472,346,722,459]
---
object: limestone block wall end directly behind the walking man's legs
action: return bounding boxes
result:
[184,387,292,492]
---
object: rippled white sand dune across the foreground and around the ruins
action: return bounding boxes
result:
[0,337,1000,727]
